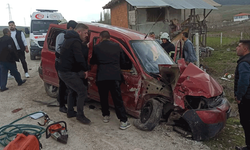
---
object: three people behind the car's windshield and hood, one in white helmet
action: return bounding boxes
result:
[149,32,197,64]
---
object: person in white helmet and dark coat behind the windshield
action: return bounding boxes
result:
[161,32,175,59]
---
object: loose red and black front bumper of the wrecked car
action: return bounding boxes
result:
[182,98,231,141]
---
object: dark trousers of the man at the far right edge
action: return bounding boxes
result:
[238,99,250,147]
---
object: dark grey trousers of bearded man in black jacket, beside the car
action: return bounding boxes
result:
[58,71,88,115]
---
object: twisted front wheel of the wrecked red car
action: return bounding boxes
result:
[134,99,163,131]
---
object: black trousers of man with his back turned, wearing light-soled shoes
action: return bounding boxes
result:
[97,80,128,122]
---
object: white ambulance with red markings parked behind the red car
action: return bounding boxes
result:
[25,9,66,60]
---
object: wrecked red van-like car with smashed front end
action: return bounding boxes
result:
[39,23,230,140]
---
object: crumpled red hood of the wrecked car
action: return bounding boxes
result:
[160,59,223,109]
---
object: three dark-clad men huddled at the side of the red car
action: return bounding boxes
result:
[55,20,131,130]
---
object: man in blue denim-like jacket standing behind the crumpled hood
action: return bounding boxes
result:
[182,32,197,64]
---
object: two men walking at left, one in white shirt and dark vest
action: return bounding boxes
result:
[0,21,30,92]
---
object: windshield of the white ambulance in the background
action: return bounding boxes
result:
[31,20,58,34]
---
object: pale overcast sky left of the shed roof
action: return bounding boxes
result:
[0,0,111,26]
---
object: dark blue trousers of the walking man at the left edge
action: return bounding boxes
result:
[0,62,23,89]
